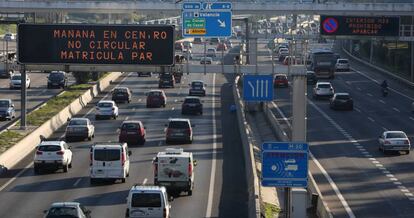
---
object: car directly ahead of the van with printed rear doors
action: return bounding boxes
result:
[165,118,194,144]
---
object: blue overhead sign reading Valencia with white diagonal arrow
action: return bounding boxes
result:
[182,2,232,38]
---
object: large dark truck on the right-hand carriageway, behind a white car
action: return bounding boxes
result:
[306,49,337,79]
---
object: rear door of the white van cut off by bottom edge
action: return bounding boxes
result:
[130,192,165,217]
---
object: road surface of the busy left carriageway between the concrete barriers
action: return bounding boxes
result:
[0,70,247,218]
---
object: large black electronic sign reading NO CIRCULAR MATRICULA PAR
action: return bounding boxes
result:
[18,24,174,65]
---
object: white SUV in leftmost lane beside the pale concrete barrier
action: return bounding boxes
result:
[33,141,73,174]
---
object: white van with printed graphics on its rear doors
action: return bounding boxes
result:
[153,148,197,195]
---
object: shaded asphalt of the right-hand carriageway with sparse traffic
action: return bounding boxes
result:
[273,41,414,217]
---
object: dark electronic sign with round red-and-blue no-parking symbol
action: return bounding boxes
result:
[320,15,400,37]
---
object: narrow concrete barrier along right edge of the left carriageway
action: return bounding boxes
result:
[233,77,260,218]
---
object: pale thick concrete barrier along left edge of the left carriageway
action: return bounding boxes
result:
[0,72,121,169]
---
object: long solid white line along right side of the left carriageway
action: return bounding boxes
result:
[206,73,217,217]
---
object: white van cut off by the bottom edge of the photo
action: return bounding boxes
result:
[125,186,171,218]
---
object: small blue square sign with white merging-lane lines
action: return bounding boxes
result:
[243,75,273,101]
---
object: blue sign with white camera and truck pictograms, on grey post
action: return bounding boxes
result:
[262,142,308,187]
